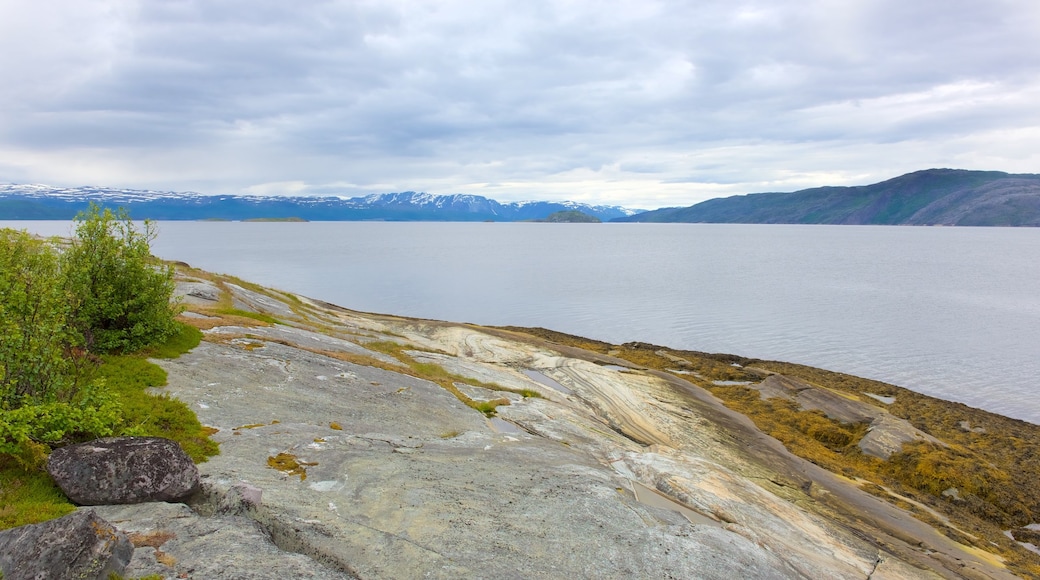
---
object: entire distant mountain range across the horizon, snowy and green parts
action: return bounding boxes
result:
[0,169,1040,227]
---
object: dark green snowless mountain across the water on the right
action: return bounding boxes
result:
[615,169,1040,227]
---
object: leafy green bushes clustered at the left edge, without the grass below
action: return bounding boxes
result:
[0,205,180,467]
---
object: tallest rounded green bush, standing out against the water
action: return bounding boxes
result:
[62,204,177,352]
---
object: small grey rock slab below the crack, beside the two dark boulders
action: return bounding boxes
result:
[85,503,349,580]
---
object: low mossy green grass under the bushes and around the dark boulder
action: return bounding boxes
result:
[0,324,218,529]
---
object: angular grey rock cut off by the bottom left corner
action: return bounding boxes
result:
[0,509,133,580]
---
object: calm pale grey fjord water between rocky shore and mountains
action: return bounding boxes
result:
[8,222,1040,423]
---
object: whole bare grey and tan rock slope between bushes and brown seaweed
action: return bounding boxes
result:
[10,268,1040,579]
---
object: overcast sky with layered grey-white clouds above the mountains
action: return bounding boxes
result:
[0,0,1040,209]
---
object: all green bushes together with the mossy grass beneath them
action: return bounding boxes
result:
[0,207,216,529]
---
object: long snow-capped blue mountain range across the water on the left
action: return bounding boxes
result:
[0,184,638,221]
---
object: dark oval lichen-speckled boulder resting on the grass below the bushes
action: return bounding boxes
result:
[47,437,199,505]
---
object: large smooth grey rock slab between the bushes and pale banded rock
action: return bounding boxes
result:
[151,343,798,578]
